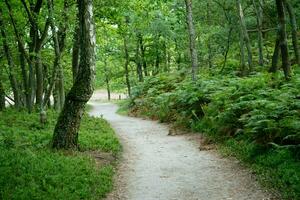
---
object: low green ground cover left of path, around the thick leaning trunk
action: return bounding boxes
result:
[0,109,121,200]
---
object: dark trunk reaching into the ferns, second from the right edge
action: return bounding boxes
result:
[276,0,291,79]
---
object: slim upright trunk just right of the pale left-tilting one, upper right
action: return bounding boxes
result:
[253,0,264,66]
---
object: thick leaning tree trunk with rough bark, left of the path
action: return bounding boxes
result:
[52,0,96,149]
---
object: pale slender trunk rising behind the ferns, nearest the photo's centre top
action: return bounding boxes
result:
[185,0,198,81]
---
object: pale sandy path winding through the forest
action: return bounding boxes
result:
[90,101,270,200]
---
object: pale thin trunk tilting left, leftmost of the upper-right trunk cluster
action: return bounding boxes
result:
[237,0,253,72]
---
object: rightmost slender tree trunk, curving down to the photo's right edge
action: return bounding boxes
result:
[283,0,300,66]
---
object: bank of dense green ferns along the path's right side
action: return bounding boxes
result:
[123,70,300,199]
